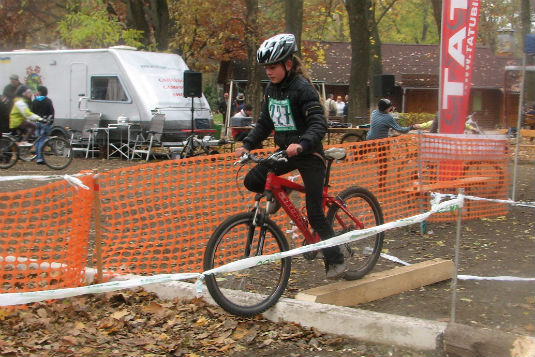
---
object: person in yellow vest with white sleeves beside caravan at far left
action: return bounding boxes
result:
[9,85,41,146]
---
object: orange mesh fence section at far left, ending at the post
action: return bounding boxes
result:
[0,176,93,292]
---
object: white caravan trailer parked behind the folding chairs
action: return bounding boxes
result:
[0,46,213,141]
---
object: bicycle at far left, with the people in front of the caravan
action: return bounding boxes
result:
[0,115,72,170]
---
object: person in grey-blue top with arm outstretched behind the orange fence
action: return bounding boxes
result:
[366,98,414,191]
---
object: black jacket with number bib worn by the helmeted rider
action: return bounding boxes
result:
[243,75,327,154]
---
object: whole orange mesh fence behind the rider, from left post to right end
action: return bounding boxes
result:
[93,135,507,274]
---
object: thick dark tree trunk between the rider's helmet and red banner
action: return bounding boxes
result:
[345,0,370,122]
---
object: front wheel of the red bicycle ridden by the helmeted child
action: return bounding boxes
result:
[204,212,291,316]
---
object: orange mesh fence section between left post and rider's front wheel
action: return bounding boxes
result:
[98,154,248,274]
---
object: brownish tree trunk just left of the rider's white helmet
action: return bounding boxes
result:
[245,0,262,122]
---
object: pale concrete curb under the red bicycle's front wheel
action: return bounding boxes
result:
[144,281,447,350]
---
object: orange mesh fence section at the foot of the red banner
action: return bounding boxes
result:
[419,134,509,221]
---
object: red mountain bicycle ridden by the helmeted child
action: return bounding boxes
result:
[203,148,384,316]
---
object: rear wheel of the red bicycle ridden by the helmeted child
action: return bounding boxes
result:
[327,186,384,280]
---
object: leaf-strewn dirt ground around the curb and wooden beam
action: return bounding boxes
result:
[0,159,535,356]
